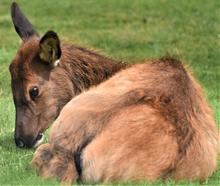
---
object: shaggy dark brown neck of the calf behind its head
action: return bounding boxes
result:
[60,45,127,96]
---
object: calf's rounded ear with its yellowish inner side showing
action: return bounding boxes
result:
[39,31,61,66]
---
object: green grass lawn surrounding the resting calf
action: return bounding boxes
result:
[0,0,220,186]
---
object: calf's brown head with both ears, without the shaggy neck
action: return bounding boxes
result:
[9,3,69,148]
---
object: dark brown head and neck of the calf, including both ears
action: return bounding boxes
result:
[9,3,126,147]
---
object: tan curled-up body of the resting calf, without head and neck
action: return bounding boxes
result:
[32,58,218,183]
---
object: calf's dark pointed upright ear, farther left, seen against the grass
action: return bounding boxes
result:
[11,2,38,41]
